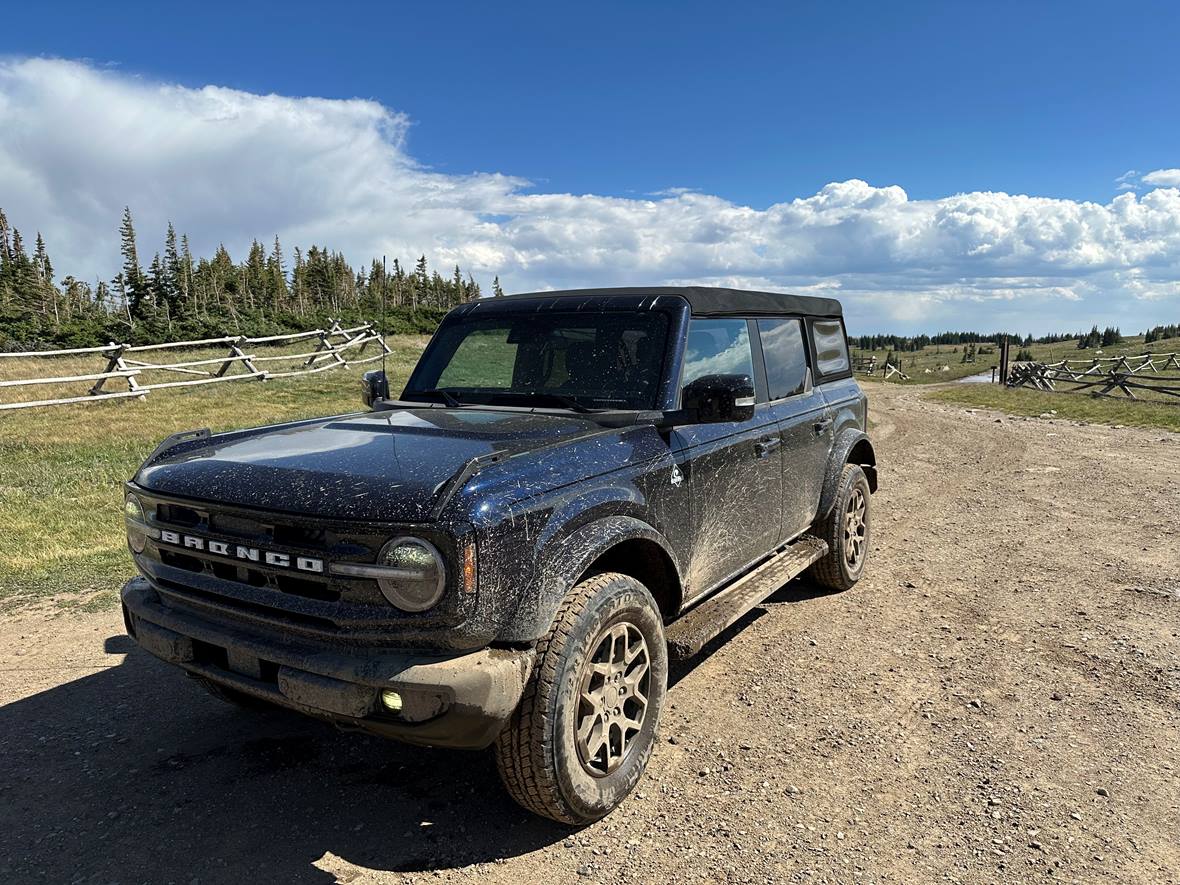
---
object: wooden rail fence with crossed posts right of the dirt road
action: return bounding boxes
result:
[1008,353,1180,399]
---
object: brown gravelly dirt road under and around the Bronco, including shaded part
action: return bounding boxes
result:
[0,386,1180,885]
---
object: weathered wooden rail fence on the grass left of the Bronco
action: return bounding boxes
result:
[0,321,391,411]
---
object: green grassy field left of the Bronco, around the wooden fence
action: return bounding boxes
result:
[0,336,427,608]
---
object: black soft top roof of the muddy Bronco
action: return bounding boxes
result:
[493,286,844,316]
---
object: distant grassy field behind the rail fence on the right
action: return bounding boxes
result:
[852,335,1180,384]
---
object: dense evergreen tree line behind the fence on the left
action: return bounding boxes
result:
[0,208,504,349]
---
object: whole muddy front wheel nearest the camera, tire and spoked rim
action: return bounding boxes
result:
[496,572,668,825]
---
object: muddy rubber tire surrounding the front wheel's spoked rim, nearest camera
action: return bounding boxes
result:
[496,572,668,826]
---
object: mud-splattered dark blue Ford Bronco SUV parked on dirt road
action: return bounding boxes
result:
[123,287,877,824]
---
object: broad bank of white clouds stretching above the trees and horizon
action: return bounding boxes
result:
[0,59,1180,330]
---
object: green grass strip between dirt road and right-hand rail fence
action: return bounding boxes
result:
[925,384,1180,433]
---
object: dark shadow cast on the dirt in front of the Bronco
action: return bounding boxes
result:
[0,636,570,885]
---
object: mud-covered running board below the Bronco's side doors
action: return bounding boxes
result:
[666,535,827,661]
